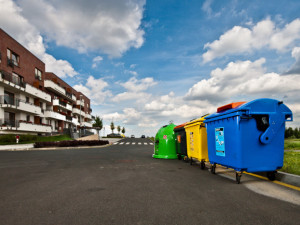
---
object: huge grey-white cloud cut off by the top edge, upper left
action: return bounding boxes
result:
[15,0,145,57]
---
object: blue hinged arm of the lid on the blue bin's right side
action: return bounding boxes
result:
[259,113,292,144]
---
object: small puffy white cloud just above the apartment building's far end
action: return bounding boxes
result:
[73,76,112,105]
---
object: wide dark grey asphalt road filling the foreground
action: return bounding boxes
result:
[0,138,300,225]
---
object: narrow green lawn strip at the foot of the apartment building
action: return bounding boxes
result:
[0,134,72,145]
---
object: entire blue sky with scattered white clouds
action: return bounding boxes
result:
[0,0,300,136]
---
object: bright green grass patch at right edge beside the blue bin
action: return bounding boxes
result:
[281,151,300,175]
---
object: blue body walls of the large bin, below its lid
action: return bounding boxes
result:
[207,115,285,172]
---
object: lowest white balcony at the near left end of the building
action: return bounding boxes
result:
[0,119,52,133]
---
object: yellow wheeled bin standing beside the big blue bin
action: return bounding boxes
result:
[184,115,208,169]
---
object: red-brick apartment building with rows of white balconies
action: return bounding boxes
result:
[0,29,92,134]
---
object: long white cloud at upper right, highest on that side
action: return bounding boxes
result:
[202,19,300,63]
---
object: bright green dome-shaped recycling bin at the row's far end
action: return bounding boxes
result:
[152,123,177,159]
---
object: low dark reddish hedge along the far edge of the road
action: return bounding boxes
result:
[34,140,109,148]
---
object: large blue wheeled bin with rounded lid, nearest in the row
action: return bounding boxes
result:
[204,99,293,183]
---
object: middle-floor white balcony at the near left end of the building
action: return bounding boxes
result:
[0,95,42,115]
